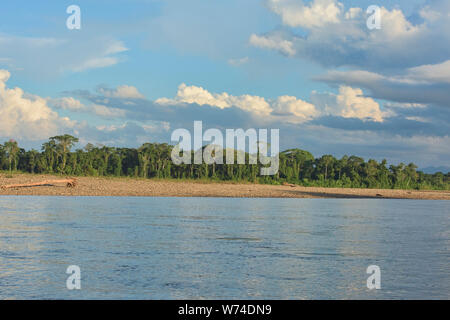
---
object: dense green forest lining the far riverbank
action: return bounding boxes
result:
[0,135,450,190]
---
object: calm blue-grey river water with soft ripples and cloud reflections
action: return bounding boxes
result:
[0,197,450,299]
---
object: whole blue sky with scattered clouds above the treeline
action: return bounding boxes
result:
[0,0,450,167]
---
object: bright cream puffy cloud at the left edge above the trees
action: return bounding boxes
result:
[0,70,74,141]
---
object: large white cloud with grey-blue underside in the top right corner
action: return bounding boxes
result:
[249,0,450,70]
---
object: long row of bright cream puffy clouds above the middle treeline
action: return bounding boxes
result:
[123,83,389,124]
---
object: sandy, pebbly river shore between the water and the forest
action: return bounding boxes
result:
[0,174,450,200]
